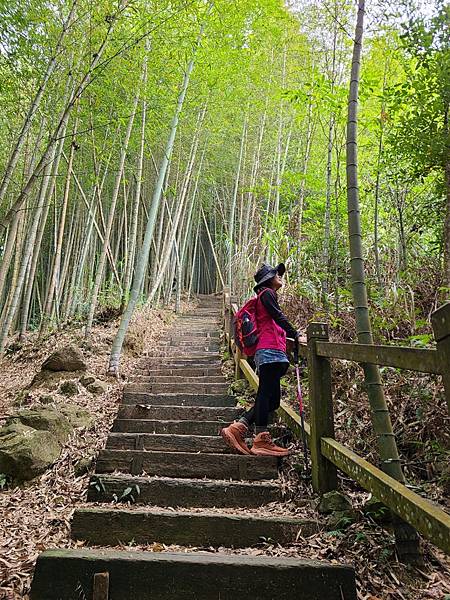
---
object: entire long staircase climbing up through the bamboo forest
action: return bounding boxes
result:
[31,296,356,600]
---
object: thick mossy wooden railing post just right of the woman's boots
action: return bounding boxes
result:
[306,323,338,494]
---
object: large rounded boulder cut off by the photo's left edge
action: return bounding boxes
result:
[0,422,61,481]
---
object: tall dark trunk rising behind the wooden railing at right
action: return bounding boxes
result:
[347,0,419,562]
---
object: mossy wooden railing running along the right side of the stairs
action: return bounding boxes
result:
[224,291,450,554]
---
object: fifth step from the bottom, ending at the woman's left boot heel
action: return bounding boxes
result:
[106,433,231,454]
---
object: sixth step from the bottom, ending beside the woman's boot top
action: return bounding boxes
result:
[112,419,225,435]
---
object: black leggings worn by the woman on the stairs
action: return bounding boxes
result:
[244,362,289,428]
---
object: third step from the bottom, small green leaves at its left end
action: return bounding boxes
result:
[87,474,281,508]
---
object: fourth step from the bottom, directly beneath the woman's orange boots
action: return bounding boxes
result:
[95,450,280,481]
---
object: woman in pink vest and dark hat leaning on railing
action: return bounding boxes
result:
[221,263,298,456]
